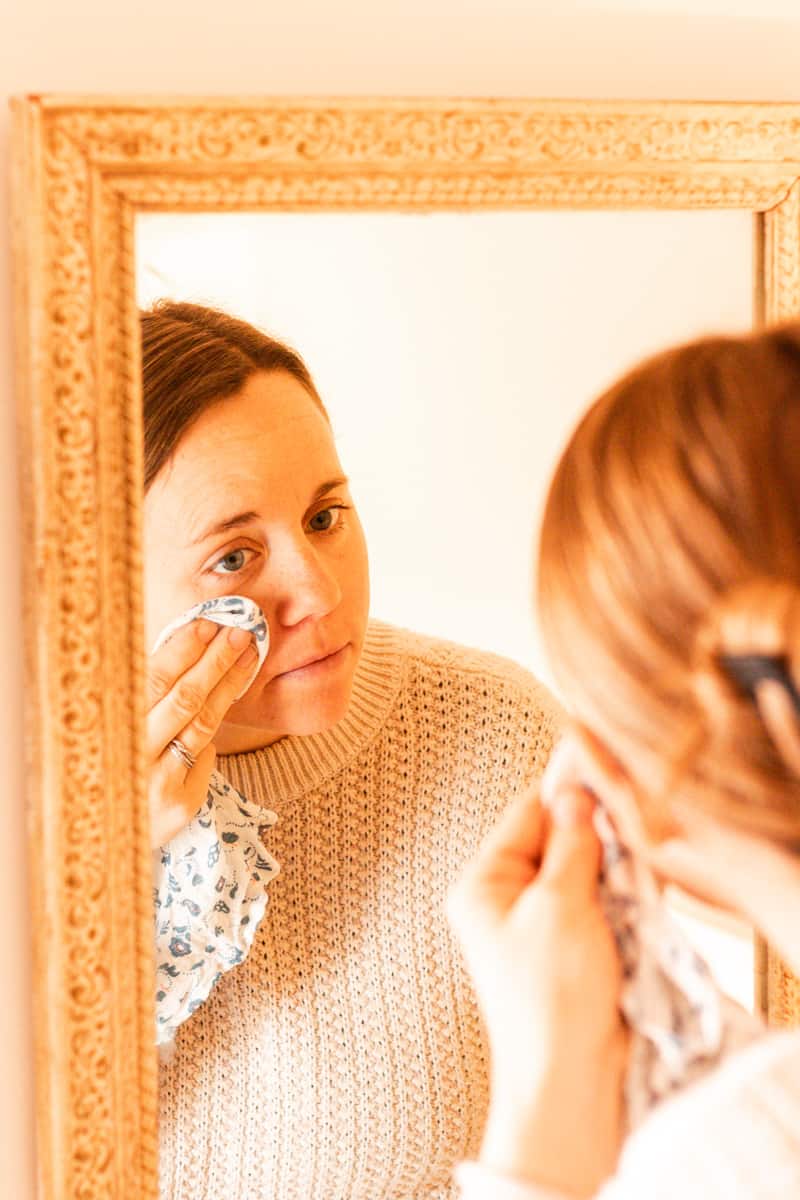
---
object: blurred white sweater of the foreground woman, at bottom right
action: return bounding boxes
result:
[456,1032,800,1200]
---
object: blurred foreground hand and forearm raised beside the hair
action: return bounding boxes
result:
[449,772,627,1196]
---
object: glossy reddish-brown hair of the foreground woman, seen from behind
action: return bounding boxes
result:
[537,325,800,838]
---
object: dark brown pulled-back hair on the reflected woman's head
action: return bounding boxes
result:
[140,300,327,491]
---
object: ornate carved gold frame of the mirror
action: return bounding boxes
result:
[9,96,800,1200]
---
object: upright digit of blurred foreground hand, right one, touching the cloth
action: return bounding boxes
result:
[539,787,602,896]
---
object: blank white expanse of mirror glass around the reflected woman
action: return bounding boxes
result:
[137,211,753,1056]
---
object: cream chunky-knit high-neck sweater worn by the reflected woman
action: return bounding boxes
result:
[155,623,557,1200]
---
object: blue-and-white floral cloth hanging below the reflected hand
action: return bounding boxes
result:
[154,770,279,1045]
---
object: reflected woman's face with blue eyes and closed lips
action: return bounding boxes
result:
[144,371,369,751]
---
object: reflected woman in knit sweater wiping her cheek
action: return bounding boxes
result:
[143,304,554,1200]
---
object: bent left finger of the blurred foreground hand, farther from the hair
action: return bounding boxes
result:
[447,788,545,925]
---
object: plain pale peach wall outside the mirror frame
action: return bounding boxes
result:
[0,0,800,1200]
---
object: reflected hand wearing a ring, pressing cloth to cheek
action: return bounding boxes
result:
[148,619,258,847]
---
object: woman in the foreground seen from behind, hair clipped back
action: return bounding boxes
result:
[451,325,800,1200]
